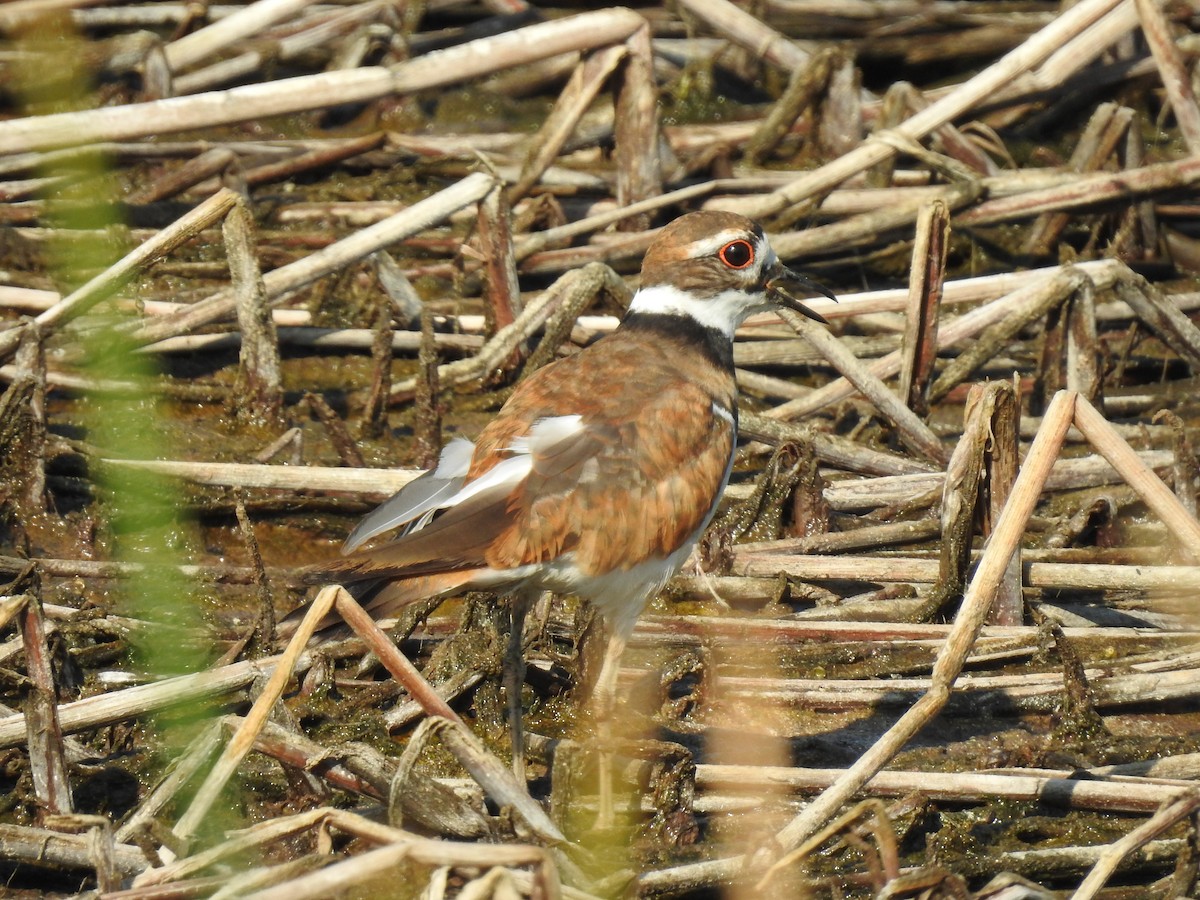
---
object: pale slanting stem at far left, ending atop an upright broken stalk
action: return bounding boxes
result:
[0,188,238,359]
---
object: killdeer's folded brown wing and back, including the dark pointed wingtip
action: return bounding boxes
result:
[314,331,734,580]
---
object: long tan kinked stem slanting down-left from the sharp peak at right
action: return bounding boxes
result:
[775,393,1078,868]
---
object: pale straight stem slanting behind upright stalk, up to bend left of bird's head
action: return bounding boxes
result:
[133,172,494,343]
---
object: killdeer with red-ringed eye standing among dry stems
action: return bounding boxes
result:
[300,211,833,763]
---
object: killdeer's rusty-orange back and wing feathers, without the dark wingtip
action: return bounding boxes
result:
[480,333,734,574]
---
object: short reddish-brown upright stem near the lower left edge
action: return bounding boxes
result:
[19,594,73,815]
